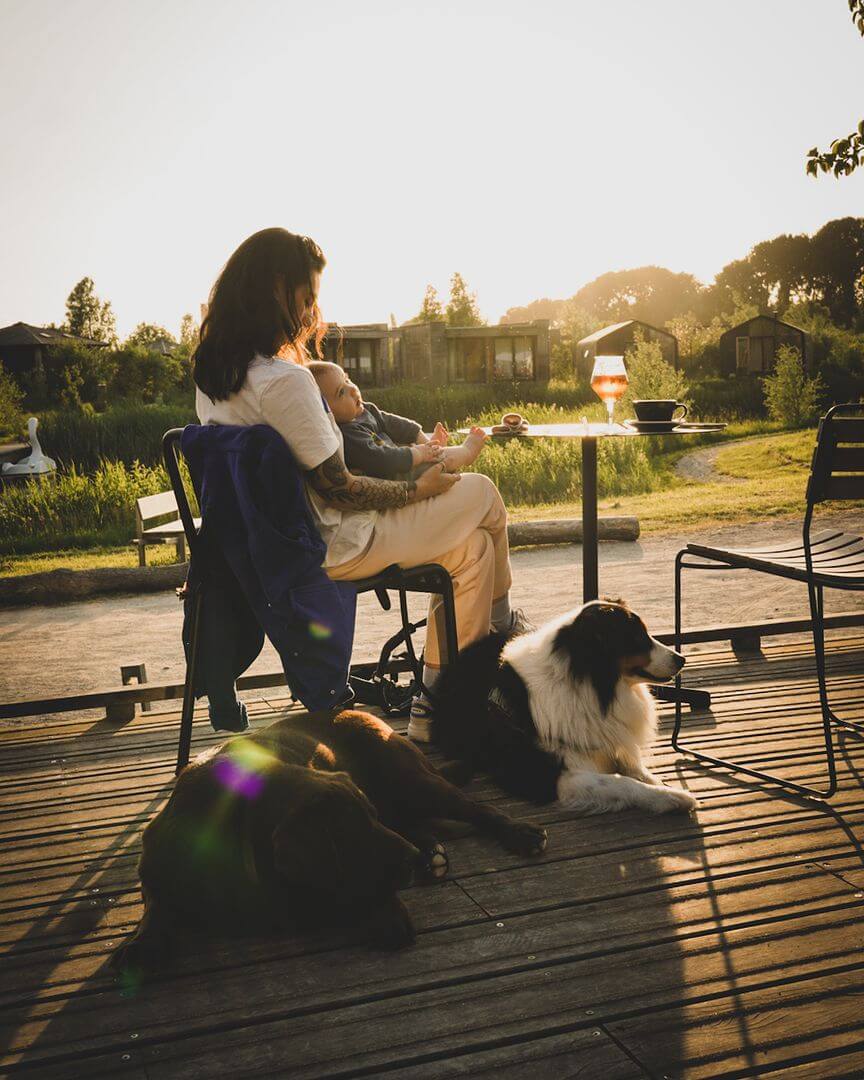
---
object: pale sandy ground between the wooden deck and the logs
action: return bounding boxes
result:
[0,515,864,701]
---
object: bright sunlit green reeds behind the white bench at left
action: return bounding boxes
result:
[0,461,170,555]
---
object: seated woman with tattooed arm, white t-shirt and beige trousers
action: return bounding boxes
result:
[193,223,527,741]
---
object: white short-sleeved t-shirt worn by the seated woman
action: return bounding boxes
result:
[195,356,377,566]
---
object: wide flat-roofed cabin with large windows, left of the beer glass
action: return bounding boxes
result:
[391,319,552,386]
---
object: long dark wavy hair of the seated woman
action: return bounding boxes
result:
[192,229,327,402]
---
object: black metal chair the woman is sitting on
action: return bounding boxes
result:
[162,428,459,773]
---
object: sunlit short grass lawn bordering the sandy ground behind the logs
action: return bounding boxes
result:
[0,431,848,575]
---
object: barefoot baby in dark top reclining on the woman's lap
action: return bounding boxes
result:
[309,360,488,480]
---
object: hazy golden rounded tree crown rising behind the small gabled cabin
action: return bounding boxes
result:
[572,267,702,326]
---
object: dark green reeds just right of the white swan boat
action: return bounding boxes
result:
[39,397,195,473]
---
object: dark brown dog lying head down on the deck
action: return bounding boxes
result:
[112,711,546,969]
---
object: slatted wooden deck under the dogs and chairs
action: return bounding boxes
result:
[0,632,864,1080]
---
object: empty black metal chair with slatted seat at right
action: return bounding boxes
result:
[672,404,864,799]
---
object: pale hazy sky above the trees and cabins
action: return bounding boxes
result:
[0,0,864,335]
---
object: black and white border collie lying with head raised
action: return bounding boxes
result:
[435,599,697,813]
